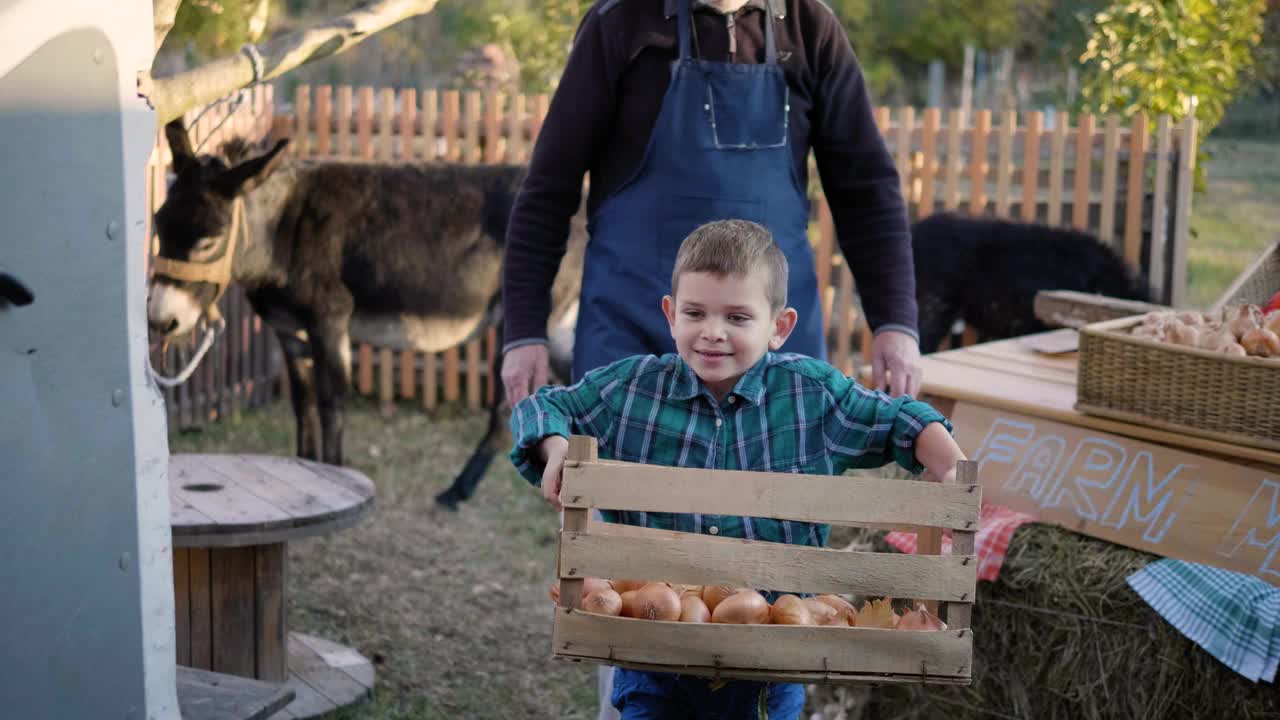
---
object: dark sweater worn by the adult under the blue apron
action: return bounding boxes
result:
[503,0,916,345]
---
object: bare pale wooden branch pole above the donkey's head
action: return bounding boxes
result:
[150,0,436,124]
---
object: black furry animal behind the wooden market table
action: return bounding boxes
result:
[911,214,1149,352]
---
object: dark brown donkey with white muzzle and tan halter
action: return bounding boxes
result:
[147,120,586,509]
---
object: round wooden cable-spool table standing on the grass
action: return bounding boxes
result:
[169,455,374,717]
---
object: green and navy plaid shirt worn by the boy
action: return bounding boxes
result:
[511,352,951,546]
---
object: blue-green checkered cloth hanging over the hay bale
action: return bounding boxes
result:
[1129,560,1280,683]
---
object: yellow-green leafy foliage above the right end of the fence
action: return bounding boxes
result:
[1080,0,1265,138]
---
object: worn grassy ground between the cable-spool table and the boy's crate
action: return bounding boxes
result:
[169,401,595,720]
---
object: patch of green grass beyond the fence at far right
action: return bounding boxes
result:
[1187,138,1280,309]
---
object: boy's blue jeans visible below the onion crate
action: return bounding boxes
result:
[613,667,804,720]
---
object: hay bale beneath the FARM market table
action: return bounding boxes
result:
[812,524,1280,720]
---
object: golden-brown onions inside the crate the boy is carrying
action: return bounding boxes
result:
[550,578,947,630]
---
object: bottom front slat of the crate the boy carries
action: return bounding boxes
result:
[553,609,973,676]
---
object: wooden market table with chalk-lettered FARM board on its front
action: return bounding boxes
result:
[922,331,1280,584]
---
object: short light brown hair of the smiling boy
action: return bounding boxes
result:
[671,220,787,313]
